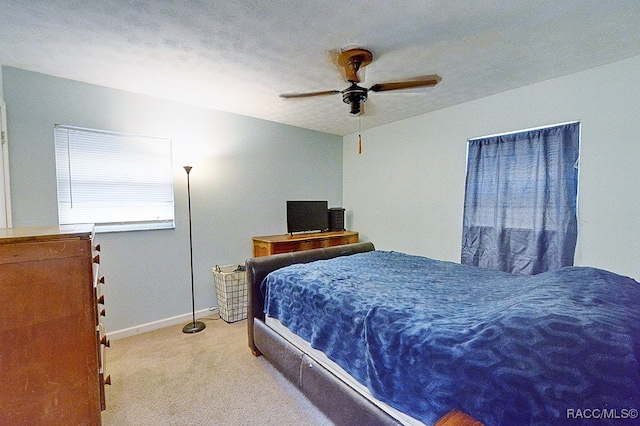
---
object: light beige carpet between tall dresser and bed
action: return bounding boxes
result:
[102,315,332,426]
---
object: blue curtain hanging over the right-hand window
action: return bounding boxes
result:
[461,123,580,275]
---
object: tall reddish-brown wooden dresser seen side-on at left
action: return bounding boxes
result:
[0,226,109,425]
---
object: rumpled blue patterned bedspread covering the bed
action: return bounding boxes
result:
[262,251,640,425]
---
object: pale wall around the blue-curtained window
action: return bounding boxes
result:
[343,56,640,280]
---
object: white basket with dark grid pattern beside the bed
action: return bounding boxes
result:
[213,265,247,322]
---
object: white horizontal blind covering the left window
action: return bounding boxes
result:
[54,125,175,232]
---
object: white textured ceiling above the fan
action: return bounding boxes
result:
[0,0,640,135]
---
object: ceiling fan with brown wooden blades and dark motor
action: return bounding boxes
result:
[280,48,442,115]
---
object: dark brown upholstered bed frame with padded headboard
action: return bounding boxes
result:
[246,242,480,426]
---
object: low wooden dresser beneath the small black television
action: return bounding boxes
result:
[253,231,358,257]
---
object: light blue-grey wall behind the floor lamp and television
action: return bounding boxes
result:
[1,67,342,332]
